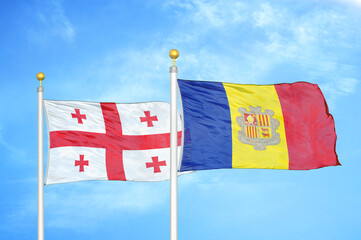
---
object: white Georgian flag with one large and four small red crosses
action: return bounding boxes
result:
[44,100,181,185]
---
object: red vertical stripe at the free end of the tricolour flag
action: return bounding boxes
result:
[275,82,340,170]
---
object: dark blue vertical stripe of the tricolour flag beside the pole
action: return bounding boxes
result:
[178,79,232,171]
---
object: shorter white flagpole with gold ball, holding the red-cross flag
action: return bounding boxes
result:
[36,72,45,240]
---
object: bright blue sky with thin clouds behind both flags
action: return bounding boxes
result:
[0,0,361,240]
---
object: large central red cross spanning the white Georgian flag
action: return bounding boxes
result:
[49,103,182,181]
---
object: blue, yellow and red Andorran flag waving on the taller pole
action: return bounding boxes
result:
[178,80,340,171]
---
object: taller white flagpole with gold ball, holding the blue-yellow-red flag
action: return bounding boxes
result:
[169,49,179,240]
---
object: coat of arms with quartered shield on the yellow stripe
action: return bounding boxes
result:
[236,106,281,151]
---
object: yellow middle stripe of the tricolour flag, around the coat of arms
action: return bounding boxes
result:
[223,83,289,169]
